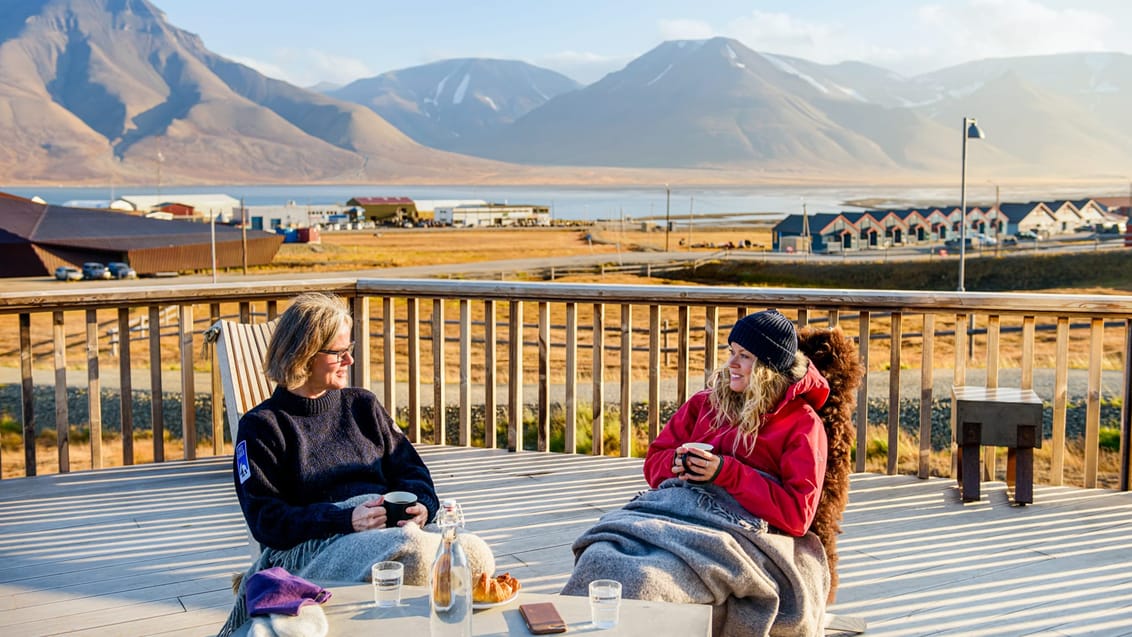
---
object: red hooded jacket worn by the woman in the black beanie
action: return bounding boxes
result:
[644,363,830,536]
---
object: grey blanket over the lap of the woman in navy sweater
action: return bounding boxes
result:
[216,496,495,637]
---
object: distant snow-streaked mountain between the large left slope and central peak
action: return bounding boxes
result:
[327,59,581,148]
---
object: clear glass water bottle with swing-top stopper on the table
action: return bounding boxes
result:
[429,499,472,637]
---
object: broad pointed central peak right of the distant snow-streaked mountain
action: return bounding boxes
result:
[452,37,945,171]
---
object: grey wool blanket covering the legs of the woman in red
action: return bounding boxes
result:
[563,480,830,637]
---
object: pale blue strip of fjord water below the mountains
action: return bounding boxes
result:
[0,184,970,223]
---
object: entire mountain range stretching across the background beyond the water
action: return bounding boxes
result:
[0,0,1132,187]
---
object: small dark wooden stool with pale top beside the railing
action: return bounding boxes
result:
[951,385,1041,505]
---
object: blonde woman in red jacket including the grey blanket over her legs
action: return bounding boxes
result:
[563,310,831,636]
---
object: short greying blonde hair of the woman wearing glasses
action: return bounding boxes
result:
[264,292,353,389]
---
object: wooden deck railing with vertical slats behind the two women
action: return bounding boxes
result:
[0,278,1132,489]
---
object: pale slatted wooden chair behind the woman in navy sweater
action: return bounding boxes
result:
[205,319,278,560]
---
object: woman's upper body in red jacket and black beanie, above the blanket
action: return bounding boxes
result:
[644,310,830,536]
